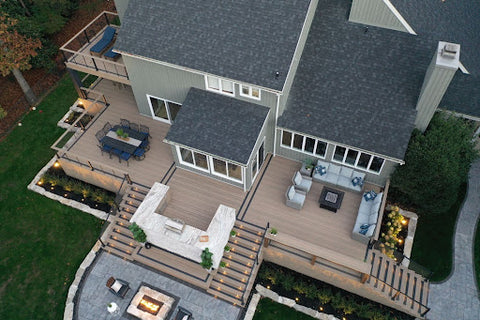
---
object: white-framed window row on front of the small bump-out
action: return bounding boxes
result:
[177,147,243,183]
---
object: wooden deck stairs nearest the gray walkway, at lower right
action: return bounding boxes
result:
[366,250,430,318]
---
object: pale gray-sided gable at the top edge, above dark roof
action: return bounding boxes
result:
[349,0,408,32]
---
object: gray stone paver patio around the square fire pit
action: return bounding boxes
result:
[75,252,241,320]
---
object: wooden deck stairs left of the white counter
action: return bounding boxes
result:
[105,185,148,260]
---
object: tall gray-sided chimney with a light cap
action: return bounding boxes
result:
[415,41,460,132]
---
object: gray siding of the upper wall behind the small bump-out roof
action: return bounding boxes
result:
[123,55,277,116]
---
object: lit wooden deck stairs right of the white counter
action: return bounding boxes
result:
[207,221,265,306]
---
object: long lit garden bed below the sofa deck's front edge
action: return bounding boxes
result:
[256,262,414,320]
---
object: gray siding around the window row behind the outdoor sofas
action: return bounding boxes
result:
[277,129,397,186]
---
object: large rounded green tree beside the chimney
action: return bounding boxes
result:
[391,112,478,214]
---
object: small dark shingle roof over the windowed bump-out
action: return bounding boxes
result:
[165,88,269,165]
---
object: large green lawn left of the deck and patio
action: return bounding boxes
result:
[0,77,101,319]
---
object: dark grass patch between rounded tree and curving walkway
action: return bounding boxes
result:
[412,183,467,281]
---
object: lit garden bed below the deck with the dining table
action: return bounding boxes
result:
[37,162,115,213]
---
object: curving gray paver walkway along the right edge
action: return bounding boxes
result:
[427,161,480,320]
